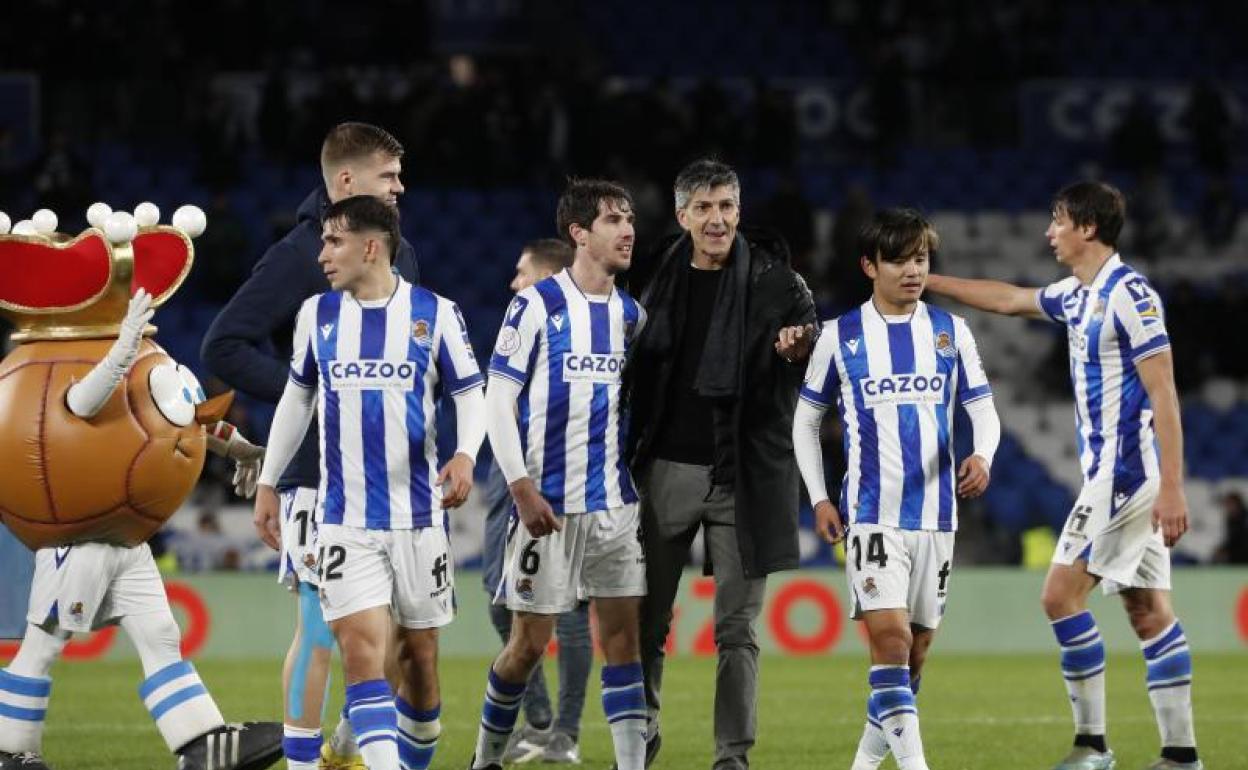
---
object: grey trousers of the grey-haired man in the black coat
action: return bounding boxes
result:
[640,461,766,770]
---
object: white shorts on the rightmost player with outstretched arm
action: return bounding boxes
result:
[1053,478,1171,594]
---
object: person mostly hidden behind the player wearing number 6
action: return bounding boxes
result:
[482,238,594,764]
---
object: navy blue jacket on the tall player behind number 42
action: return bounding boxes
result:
[200,188,421,488]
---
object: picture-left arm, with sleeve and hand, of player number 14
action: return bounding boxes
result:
[792,322,845,544]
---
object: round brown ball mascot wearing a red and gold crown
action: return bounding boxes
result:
[0,203,282,770]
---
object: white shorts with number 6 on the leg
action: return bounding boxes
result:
[494,503,645,615]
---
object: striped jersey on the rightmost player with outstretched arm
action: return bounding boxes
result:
[1036,255,1169,492]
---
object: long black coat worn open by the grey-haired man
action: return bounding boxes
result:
[625,230,816,577]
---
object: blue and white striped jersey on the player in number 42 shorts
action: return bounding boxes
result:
[291,280,483,529]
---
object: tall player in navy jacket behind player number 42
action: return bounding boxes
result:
[202,122,419,770]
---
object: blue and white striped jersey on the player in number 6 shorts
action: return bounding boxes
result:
[489,270,645,513]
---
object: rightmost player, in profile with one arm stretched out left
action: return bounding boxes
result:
[929,182,1202,770]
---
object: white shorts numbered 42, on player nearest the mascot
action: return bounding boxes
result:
[317,524,456,629]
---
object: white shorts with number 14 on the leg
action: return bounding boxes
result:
[845,524,953,629]
